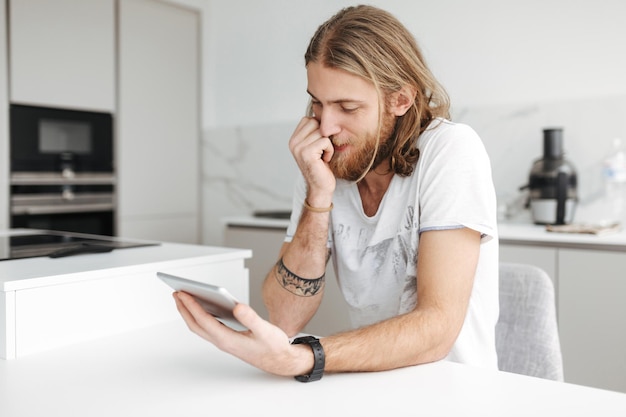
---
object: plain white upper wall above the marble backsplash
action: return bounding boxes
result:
[204,0,626,126]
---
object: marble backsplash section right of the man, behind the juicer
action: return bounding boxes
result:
[454,96,626,222]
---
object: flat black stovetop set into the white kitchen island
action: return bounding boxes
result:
[0,230,159,261]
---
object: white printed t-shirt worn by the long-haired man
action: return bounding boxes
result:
[285,120,499,369]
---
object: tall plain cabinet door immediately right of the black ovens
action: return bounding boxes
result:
[117,0,200,243]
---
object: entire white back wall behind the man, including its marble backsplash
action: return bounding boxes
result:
[198,0,626,244]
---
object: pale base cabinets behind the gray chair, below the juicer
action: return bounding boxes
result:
[500,243,626,392]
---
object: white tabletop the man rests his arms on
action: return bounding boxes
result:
[0,320,626,417]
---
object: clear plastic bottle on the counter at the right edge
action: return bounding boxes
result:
[602,138,626,225]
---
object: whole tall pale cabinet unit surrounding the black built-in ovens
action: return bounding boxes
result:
[0,0,202,243]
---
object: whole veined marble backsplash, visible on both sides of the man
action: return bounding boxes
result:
[202,96,626,245]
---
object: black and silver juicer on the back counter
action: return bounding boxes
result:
[528,128,578,224]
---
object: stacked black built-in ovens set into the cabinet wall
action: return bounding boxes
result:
[10,104,115,236]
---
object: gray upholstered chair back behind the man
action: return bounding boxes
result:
[496,263,563,381]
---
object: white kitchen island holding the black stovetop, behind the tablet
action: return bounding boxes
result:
[0,231,252,358]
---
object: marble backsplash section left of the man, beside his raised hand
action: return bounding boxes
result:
[201,121,298,245]
